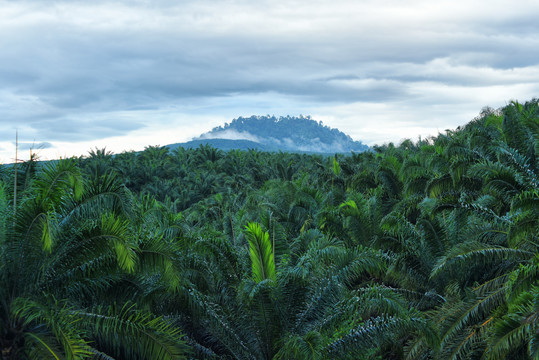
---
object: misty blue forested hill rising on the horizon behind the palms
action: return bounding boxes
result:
[170,115,369,153]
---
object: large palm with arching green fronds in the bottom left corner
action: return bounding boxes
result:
[0,160,190,359]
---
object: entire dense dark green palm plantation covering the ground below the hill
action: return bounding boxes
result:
[0,100,539,359]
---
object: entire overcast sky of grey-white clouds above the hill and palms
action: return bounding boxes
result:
[0,0,539,162]
